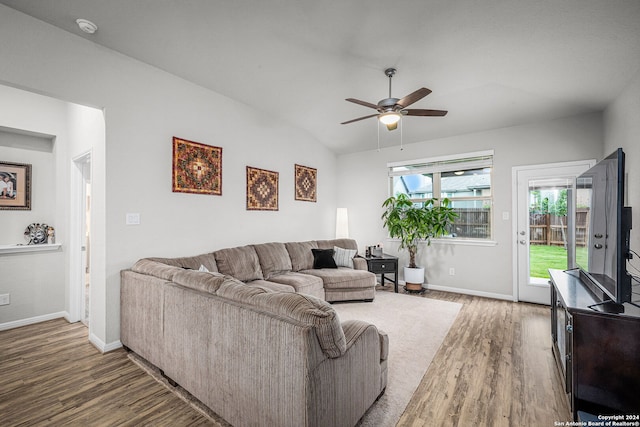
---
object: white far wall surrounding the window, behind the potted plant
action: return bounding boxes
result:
[338,113,603,299]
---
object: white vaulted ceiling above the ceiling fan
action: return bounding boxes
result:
[0,0,640,153]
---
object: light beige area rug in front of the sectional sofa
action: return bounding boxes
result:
[333,291,462,427]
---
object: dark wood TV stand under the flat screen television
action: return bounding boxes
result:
[549,270,640,421]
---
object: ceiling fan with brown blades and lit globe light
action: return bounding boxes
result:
[341,68,447,130]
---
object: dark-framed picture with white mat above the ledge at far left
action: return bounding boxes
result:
[0,161,31,210]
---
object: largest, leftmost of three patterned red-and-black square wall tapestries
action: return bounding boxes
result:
[172,136,222,196]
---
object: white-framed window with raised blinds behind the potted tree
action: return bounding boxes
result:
[387,151,493,240]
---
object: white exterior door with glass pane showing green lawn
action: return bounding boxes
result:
[513,161,594,305]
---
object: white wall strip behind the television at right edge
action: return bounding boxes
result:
[604,72,640,258]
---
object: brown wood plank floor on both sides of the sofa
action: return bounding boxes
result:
[0,287,571,426]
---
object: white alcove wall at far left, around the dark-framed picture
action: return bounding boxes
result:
[0,86,68,324]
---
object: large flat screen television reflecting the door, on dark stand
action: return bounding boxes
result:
[574,148,631,304]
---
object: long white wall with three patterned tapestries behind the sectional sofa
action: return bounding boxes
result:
[0,5,337,345]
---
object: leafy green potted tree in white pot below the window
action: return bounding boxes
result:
[382,193,458,291]
